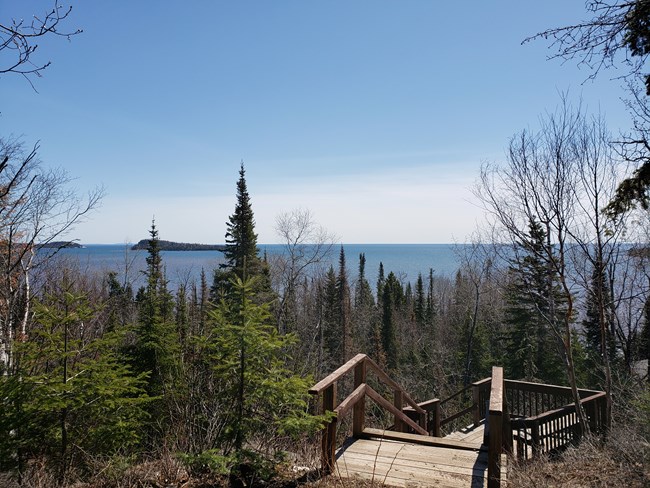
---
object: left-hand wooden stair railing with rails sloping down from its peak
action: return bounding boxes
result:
[309,354,428,473]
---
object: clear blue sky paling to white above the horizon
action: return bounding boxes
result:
[0,0,629,243]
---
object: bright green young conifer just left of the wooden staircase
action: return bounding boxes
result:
[209,279,321,454]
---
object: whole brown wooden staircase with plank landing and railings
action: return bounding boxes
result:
[309,354,607,488]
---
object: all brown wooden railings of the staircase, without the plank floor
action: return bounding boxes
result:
[309,354,608,478]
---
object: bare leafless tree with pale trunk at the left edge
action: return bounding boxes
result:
[0,139,103,373]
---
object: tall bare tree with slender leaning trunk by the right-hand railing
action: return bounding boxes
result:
[476,99,620,432]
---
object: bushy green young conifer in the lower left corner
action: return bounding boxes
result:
[0,291,148,482]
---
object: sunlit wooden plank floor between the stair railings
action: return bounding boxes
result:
[333,425,506,488]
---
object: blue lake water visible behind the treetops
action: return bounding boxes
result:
[57,244,458,289]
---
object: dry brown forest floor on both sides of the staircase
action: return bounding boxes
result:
[0,426,650,488]
